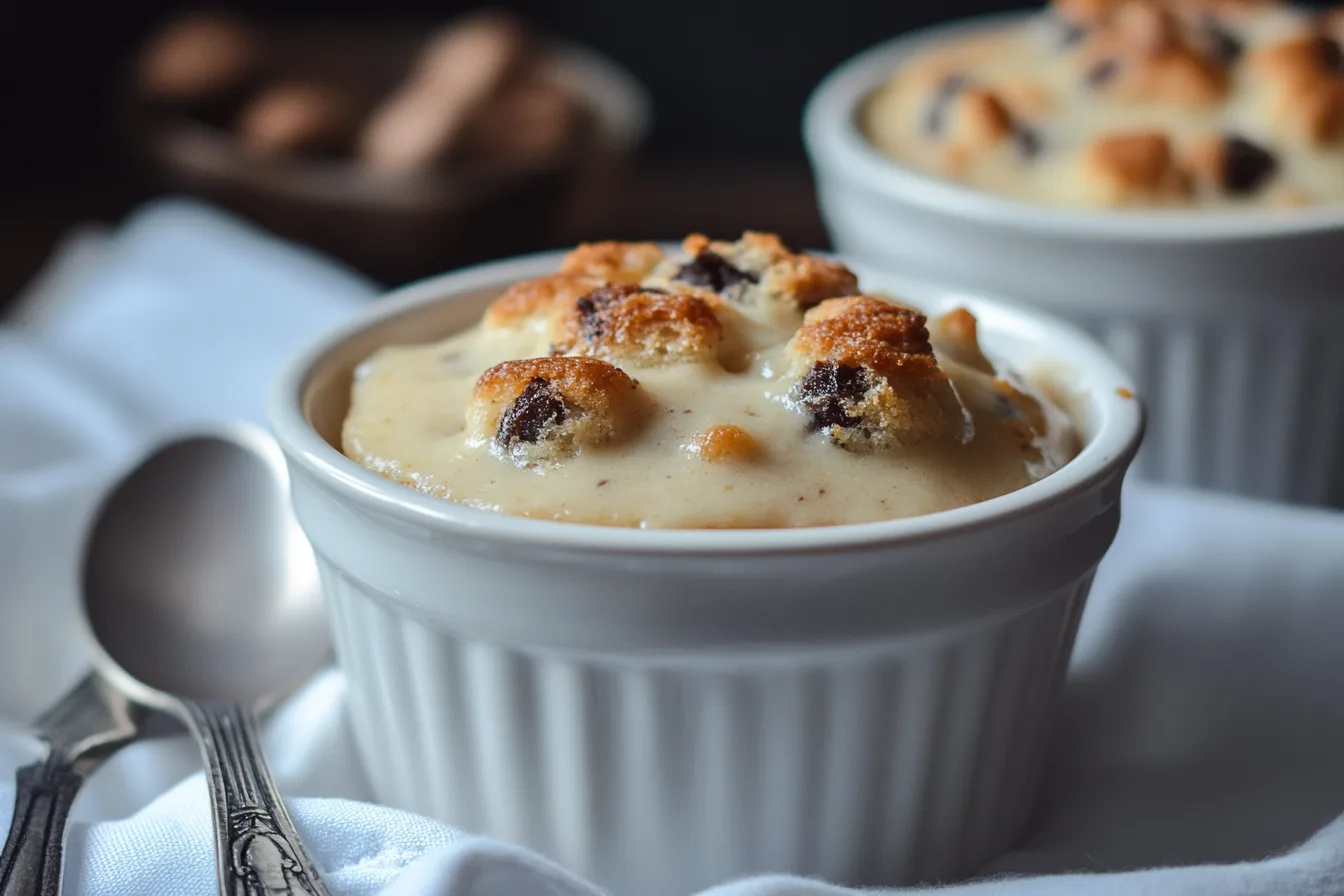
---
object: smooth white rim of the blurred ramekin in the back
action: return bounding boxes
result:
[802,11,1344,243]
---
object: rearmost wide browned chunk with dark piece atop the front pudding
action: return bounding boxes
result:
[644,231,859,310]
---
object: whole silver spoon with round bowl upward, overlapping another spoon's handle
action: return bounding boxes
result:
[83,424,331,896]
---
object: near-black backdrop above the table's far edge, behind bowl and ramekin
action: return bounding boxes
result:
[0,0,1031,173]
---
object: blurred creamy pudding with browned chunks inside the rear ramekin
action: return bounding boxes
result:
[860,0,1344,208]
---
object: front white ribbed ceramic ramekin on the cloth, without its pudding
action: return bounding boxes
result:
[270,254,1142,896]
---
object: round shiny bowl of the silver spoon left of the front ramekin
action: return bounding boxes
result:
[83,426,331,705]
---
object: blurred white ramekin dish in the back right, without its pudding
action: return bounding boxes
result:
[804,16,1344,504]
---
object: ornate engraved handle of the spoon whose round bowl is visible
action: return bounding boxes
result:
[183,701,327,896]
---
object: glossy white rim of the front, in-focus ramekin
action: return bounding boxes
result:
[267,250,1145,555]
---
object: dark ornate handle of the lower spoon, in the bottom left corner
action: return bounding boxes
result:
[0,674,145,896]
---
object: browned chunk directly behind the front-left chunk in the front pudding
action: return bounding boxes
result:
[552,283,722,367]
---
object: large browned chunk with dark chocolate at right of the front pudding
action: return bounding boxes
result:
[789,296,965,451]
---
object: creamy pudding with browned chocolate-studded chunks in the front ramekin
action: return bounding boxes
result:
[343,232,1074,528]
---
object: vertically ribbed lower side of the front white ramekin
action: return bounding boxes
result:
[323,562,1090,896]
